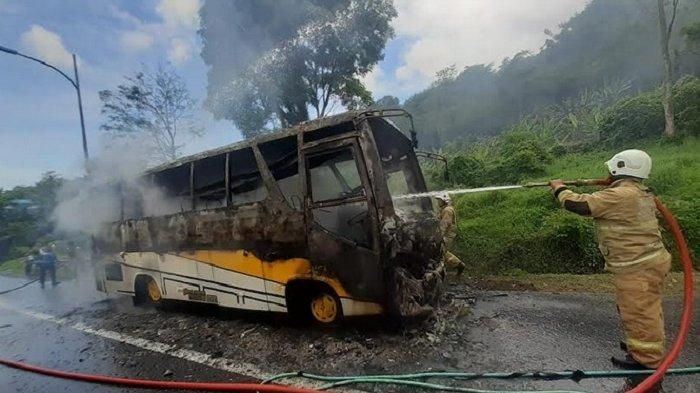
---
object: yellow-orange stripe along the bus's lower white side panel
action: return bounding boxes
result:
[177,250,350,297]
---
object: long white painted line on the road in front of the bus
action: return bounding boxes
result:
[0,300,360,393]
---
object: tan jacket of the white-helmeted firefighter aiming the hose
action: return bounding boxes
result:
[555,179,671,273]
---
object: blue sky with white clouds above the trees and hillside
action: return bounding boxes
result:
[0,0,590,189]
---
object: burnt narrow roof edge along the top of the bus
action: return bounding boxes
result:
[144,109,416,175]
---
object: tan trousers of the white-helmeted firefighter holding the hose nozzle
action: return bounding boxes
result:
[615,260,671,368]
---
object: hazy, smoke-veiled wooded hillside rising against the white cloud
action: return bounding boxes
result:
[404,0,700,148]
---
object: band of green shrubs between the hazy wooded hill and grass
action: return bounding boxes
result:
[426,76,700,188]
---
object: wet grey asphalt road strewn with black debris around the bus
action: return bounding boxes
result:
[0,275,700,392]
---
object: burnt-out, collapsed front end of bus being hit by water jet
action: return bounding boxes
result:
[368,115,445,318]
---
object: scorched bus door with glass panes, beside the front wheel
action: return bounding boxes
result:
[302,137,383,301]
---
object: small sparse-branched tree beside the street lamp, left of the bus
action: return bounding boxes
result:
[99,65,203,160]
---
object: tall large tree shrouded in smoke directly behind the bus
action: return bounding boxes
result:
[199,0,396,137]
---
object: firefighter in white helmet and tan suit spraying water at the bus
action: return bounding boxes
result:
[550,150,671,369]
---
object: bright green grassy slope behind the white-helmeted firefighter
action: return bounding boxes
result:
[453,138,700,275]
